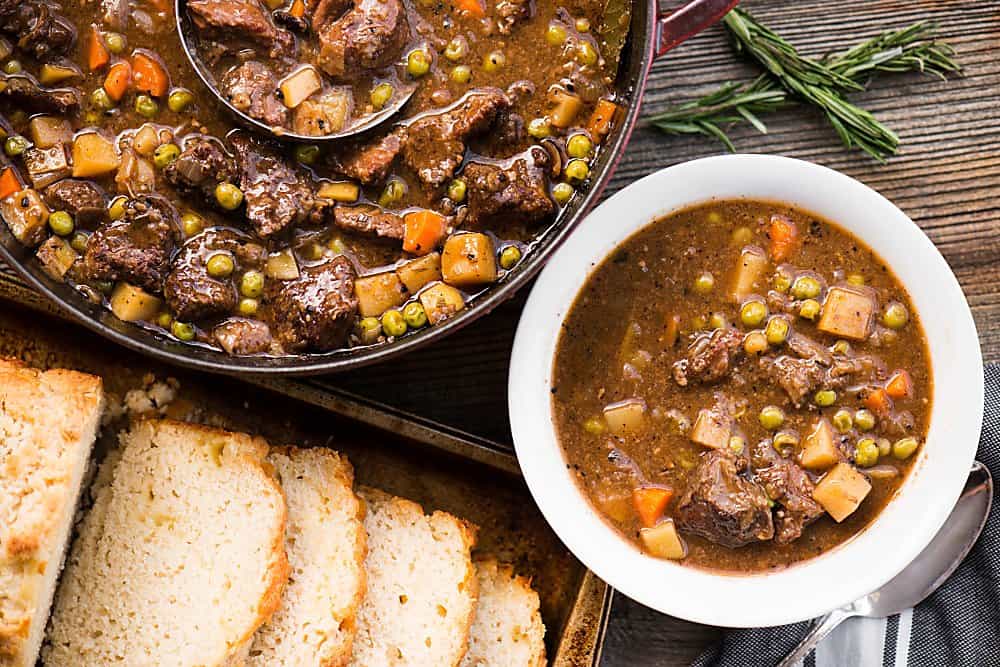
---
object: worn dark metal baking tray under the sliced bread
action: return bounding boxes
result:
[0,266,611,667]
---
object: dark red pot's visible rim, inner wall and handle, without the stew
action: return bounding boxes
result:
[0,0,737,375]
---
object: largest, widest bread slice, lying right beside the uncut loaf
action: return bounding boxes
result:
[42,420,288,667]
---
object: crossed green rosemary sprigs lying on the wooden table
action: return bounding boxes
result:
[650,9,960,160]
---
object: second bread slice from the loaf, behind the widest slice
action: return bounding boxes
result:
[248,447,366,667]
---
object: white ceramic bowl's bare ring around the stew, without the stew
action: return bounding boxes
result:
[509,155,983,627]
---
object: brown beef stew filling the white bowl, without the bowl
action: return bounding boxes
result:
[552,201,932,572]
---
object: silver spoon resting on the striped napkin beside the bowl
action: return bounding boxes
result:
[778,461,993,667]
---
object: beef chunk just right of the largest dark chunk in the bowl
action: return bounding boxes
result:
[750,440,824,544]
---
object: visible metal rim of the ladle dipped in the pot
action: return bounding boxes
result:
[174,0,417,143]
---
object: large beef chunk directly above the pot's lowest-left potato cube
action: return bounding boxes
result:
[81,195,180,294]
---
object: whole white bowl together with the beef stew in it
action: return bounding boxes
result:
[509,155,983,627]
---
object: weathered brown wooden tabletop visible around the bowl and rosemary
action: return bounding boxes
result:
[308,0,1000,667]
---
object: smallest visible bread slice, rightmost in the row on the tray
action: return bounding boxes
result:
[462,558,545,667]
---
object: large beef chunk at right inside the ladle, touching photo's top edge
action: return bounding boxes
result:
[313,0,410,79]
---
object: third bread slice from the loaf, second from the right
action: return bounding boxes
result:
[351,489,476,667]
